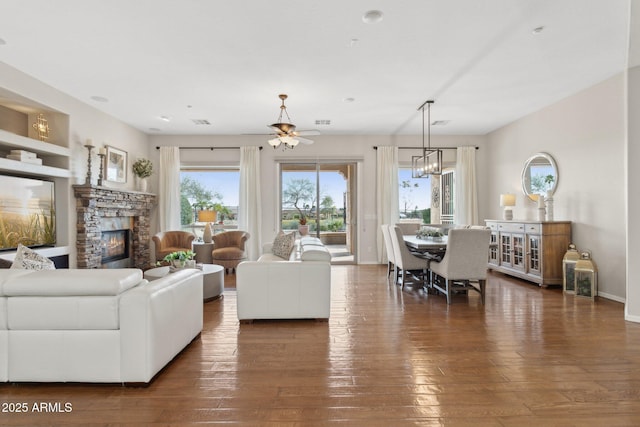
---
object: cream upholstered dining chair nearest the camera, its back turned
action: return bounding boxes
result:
[429,228,491,305]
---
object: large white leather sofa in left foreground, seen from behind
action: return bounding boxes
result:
[0,268,202,384]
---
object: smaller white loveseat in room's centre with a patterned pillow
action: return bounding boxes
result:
[236,237,331,321]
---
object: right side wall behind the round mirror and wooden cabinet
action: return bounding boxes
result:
[485,74,627,301]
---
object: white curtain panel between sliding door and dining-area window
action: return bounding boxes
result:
[376,147,400,264]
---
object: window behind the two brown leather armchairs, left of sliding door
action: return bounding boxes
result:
[180,168,240,237]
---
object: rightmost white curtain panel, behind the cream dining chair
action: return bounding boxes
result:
[454,147,479,225]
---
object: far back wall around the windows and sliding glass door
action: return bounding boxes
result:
[151,135,487,264]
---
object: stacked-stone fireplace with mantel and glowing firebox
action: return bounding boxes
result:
[73,185,156,268]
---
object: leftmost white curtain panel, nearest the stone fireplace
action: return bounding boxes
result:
[158,147,180,231]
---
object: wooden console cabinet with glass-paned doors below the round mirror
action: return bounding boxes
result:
[485,220,571,286]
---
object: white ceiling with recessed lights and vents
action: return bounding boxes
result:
[0,0,629,135]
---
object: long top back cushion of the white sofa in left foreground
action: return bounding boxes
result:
[3,268,142,296]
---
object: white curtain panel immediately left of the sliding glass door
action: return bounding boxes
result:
[238,147,262,261]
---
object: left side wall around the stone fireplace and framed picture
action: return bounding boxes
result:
[0,62,151,268]
